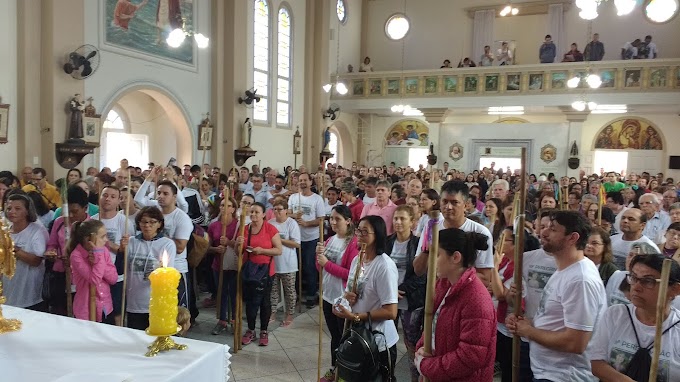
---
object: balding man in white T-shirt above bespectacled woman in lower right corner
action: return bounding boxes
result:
[611,208,659,271]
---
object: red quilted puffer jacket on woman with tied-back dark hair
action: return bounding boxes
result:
[416,268,496,382]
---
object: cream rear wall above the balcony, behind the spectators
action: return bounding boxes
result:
[363,0,680,70]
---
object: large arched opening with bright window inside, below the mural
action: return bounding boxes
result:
[91,87,195,170]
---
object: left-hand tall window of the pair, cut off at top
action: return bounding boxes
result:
[253,0,269,123]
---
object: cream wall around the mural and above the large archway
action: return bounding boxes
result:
[82,0,211,166]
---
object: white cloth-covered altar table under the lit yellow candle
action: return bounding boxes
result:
[0,305,230,382]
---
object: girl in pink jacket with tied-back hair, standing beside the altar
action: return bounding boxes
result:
[66,220,118,324]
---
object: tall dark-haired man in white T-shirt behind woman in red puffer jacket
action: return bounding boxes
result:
[413,180,494,285]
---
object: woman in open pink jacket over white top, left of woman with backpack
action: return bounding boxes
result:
[316,204,359,382]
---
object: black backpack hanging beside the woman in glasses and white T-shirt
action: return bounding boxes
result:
[335,313,389,382]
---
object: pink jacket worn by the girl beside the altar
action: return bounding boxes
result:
[71,244,118,322]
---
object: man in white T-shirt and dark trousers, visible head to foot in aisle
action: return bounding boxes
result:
[288,172,326,308]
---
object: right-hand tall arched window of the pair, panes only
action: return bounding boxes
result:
[276,7,292,126]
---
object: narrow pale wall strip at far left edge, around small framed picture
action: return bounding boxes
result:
[0,0,17,174]
